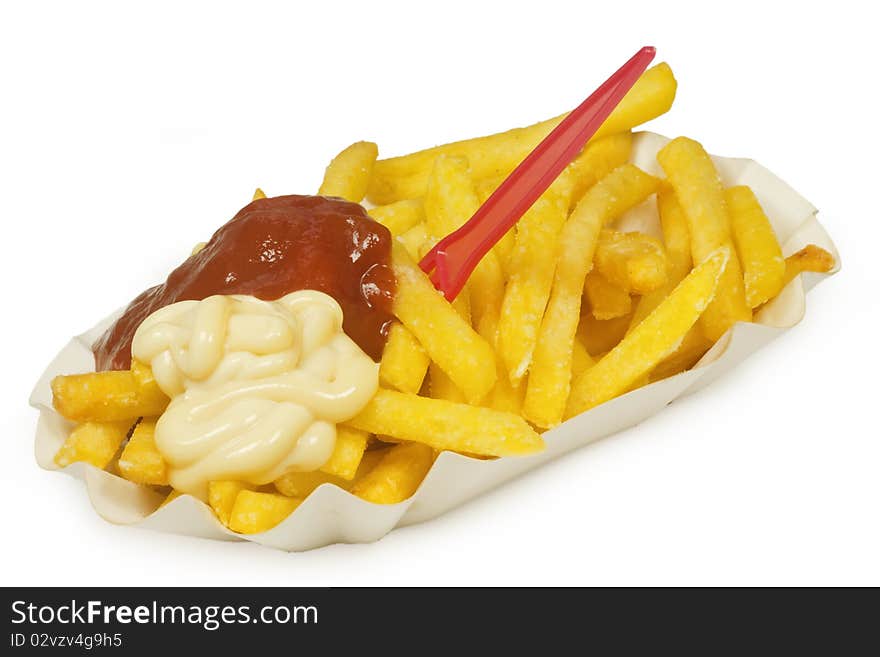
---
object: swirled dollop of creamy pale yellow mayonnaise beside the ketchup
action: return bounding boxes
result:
[131,290,379,498]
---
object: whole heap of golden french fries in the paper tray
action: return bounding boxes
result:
[51,56,834,534]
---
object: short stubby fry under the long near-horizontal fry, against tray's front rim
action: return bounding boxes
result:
[351,443,434,504]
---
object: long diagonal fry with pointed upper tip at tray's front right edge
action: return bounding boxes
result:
[566,246,733,417]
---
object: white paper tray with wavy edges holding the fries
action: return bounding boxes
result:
[30,132,840,551]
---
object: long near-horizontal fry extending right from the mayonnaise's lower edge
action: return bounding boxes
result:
[348,390,544,456]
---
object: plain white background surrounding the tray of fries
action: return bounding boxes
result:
[0,0,880,585]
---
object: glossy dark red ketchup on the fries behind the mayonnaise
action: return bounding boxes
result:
[92,195,395,371]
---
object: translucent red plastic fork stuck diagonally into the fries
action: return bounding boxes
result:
[419,46,656,301]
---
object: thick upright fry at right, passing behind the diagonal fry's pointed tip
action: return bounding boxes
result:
[657,137,752,342]
